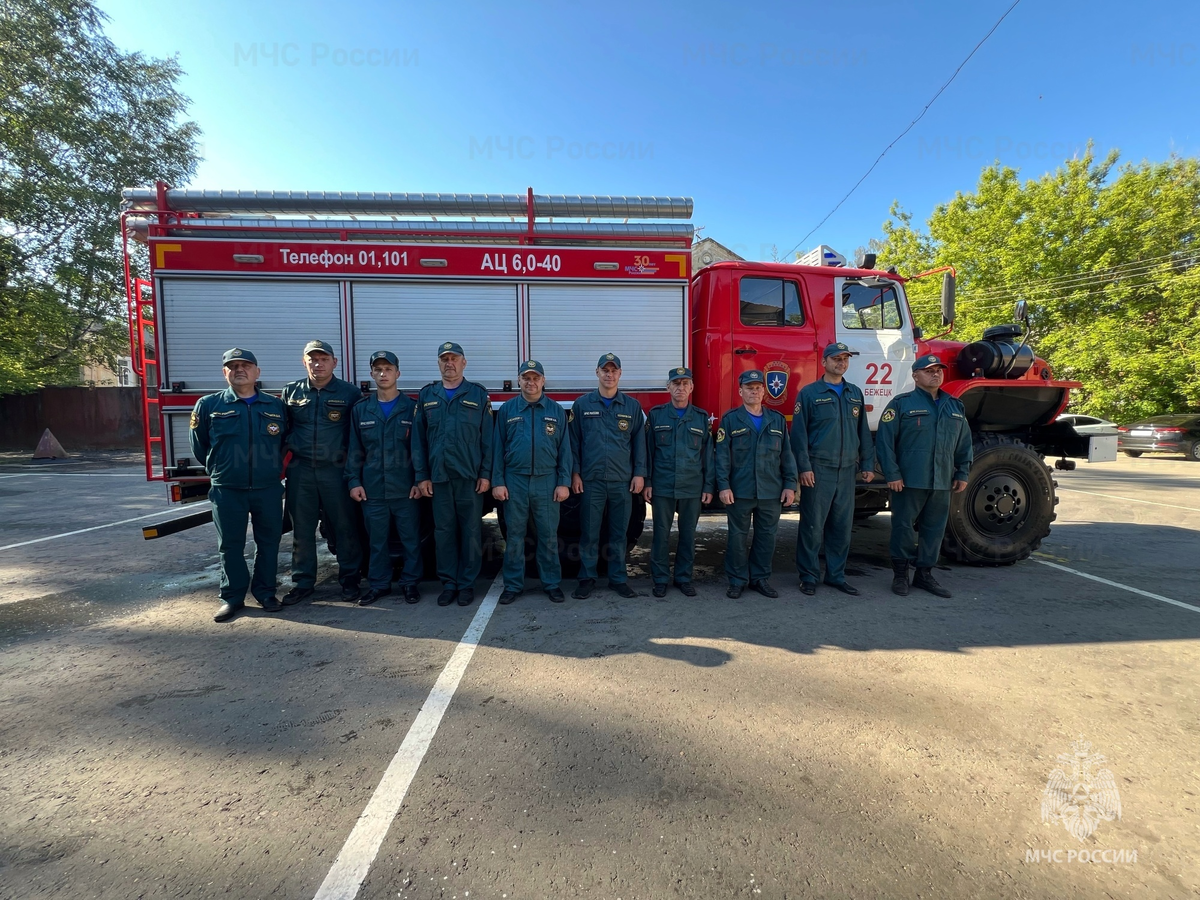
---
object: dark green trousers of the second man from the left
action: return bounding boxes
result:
[287,462,362,588]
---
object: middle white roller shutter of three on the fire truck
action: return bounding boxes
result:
[352,281,521,391]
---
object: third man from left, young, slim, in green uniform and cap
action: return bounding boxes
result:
[346,350,421,606]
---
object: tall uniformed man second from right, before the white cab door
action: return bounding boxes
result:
[792,343,875,596]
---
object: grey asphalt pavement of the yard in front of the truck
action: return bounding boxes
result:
[0,456,1200,900]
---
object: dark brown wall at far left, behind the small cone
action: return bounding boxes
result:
[0,388,142,454]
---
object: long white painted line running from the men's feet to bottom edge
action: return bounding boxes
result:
[313,574,504,900]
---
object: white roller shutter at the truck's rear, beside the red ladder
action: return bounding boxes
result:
[158,278,342,392]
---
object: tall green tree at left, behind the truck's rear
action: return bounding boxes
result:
[0,0,199,394]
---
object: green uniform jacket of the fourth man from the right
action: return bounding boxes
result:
[646,403,716,499]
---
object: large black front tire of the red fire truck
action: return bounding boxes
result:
[942,434,1058,565]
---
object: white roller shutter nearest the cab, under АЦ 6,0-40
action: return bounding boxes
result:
[529,284,686,390]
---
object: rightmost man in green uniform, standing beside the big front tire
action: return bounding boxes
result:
[875,354,974,596]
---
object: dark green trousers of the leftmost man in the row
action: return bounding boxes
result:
[209,485,283,606]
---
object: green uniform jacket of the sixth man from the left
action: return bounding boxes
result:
[566,390,646,484]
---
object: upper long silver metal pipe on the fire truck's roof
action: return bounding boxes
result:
[121,187,692,218]
